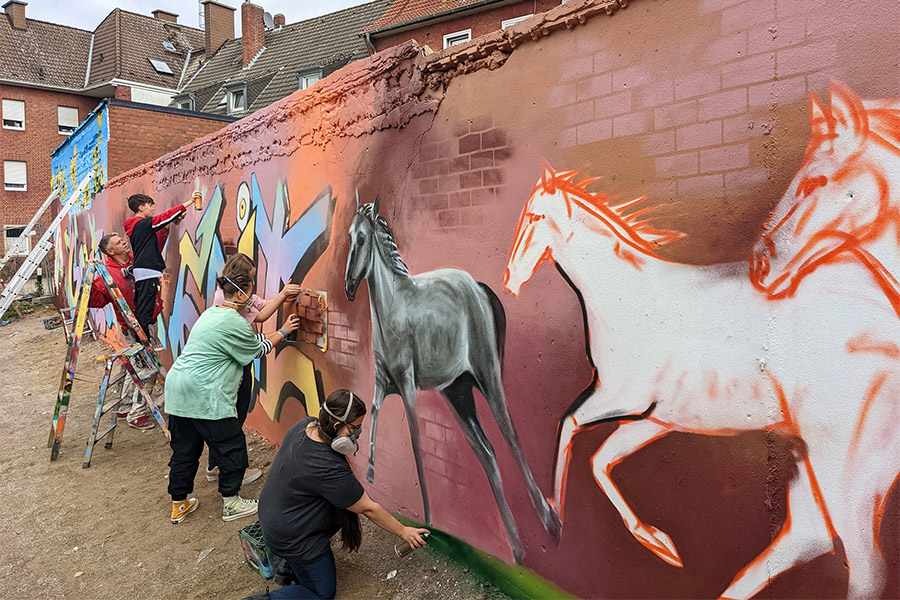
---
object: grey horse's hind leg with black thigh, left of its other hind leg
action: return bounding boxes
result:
[443,380,525,564]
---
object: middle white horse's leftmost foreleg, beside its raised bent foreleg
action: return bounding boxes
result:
[550,379,653,519]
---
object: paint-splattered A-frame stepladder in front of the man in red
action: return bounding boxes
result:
[47,259,171,461]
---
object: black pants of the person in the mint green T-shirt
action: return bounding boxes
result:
[169,415,250,502]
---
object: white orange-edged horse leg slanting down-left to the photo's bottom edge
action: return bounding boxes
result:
[722,458,834,598]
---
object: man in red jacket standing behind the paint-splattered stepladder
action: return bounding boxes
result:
[88,233,162,429]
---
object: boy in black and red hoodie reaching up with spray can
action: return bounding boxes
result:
[124,192,200,339]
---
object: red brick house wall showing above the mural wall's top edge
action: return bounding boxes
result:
[372,0,560,51]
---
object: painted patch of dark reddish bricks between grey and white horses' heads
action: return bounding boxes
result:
[411,115,510,229]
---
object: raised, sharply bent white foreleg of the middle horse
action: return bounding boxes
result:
[591,419,684,567]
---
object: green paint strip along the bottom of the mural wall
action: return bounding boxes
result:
[397,515,575,600]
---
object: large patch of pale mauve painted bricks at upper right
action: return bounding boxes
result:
[549,0,838,209]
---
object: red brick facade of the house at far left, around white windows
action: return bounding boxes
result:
[0,85,99,233]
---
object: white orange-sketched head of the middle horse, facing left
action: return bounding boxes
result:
[503,164,559,296]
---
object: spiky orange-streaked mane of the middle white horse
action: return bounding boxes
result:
[539,167,687,253]
